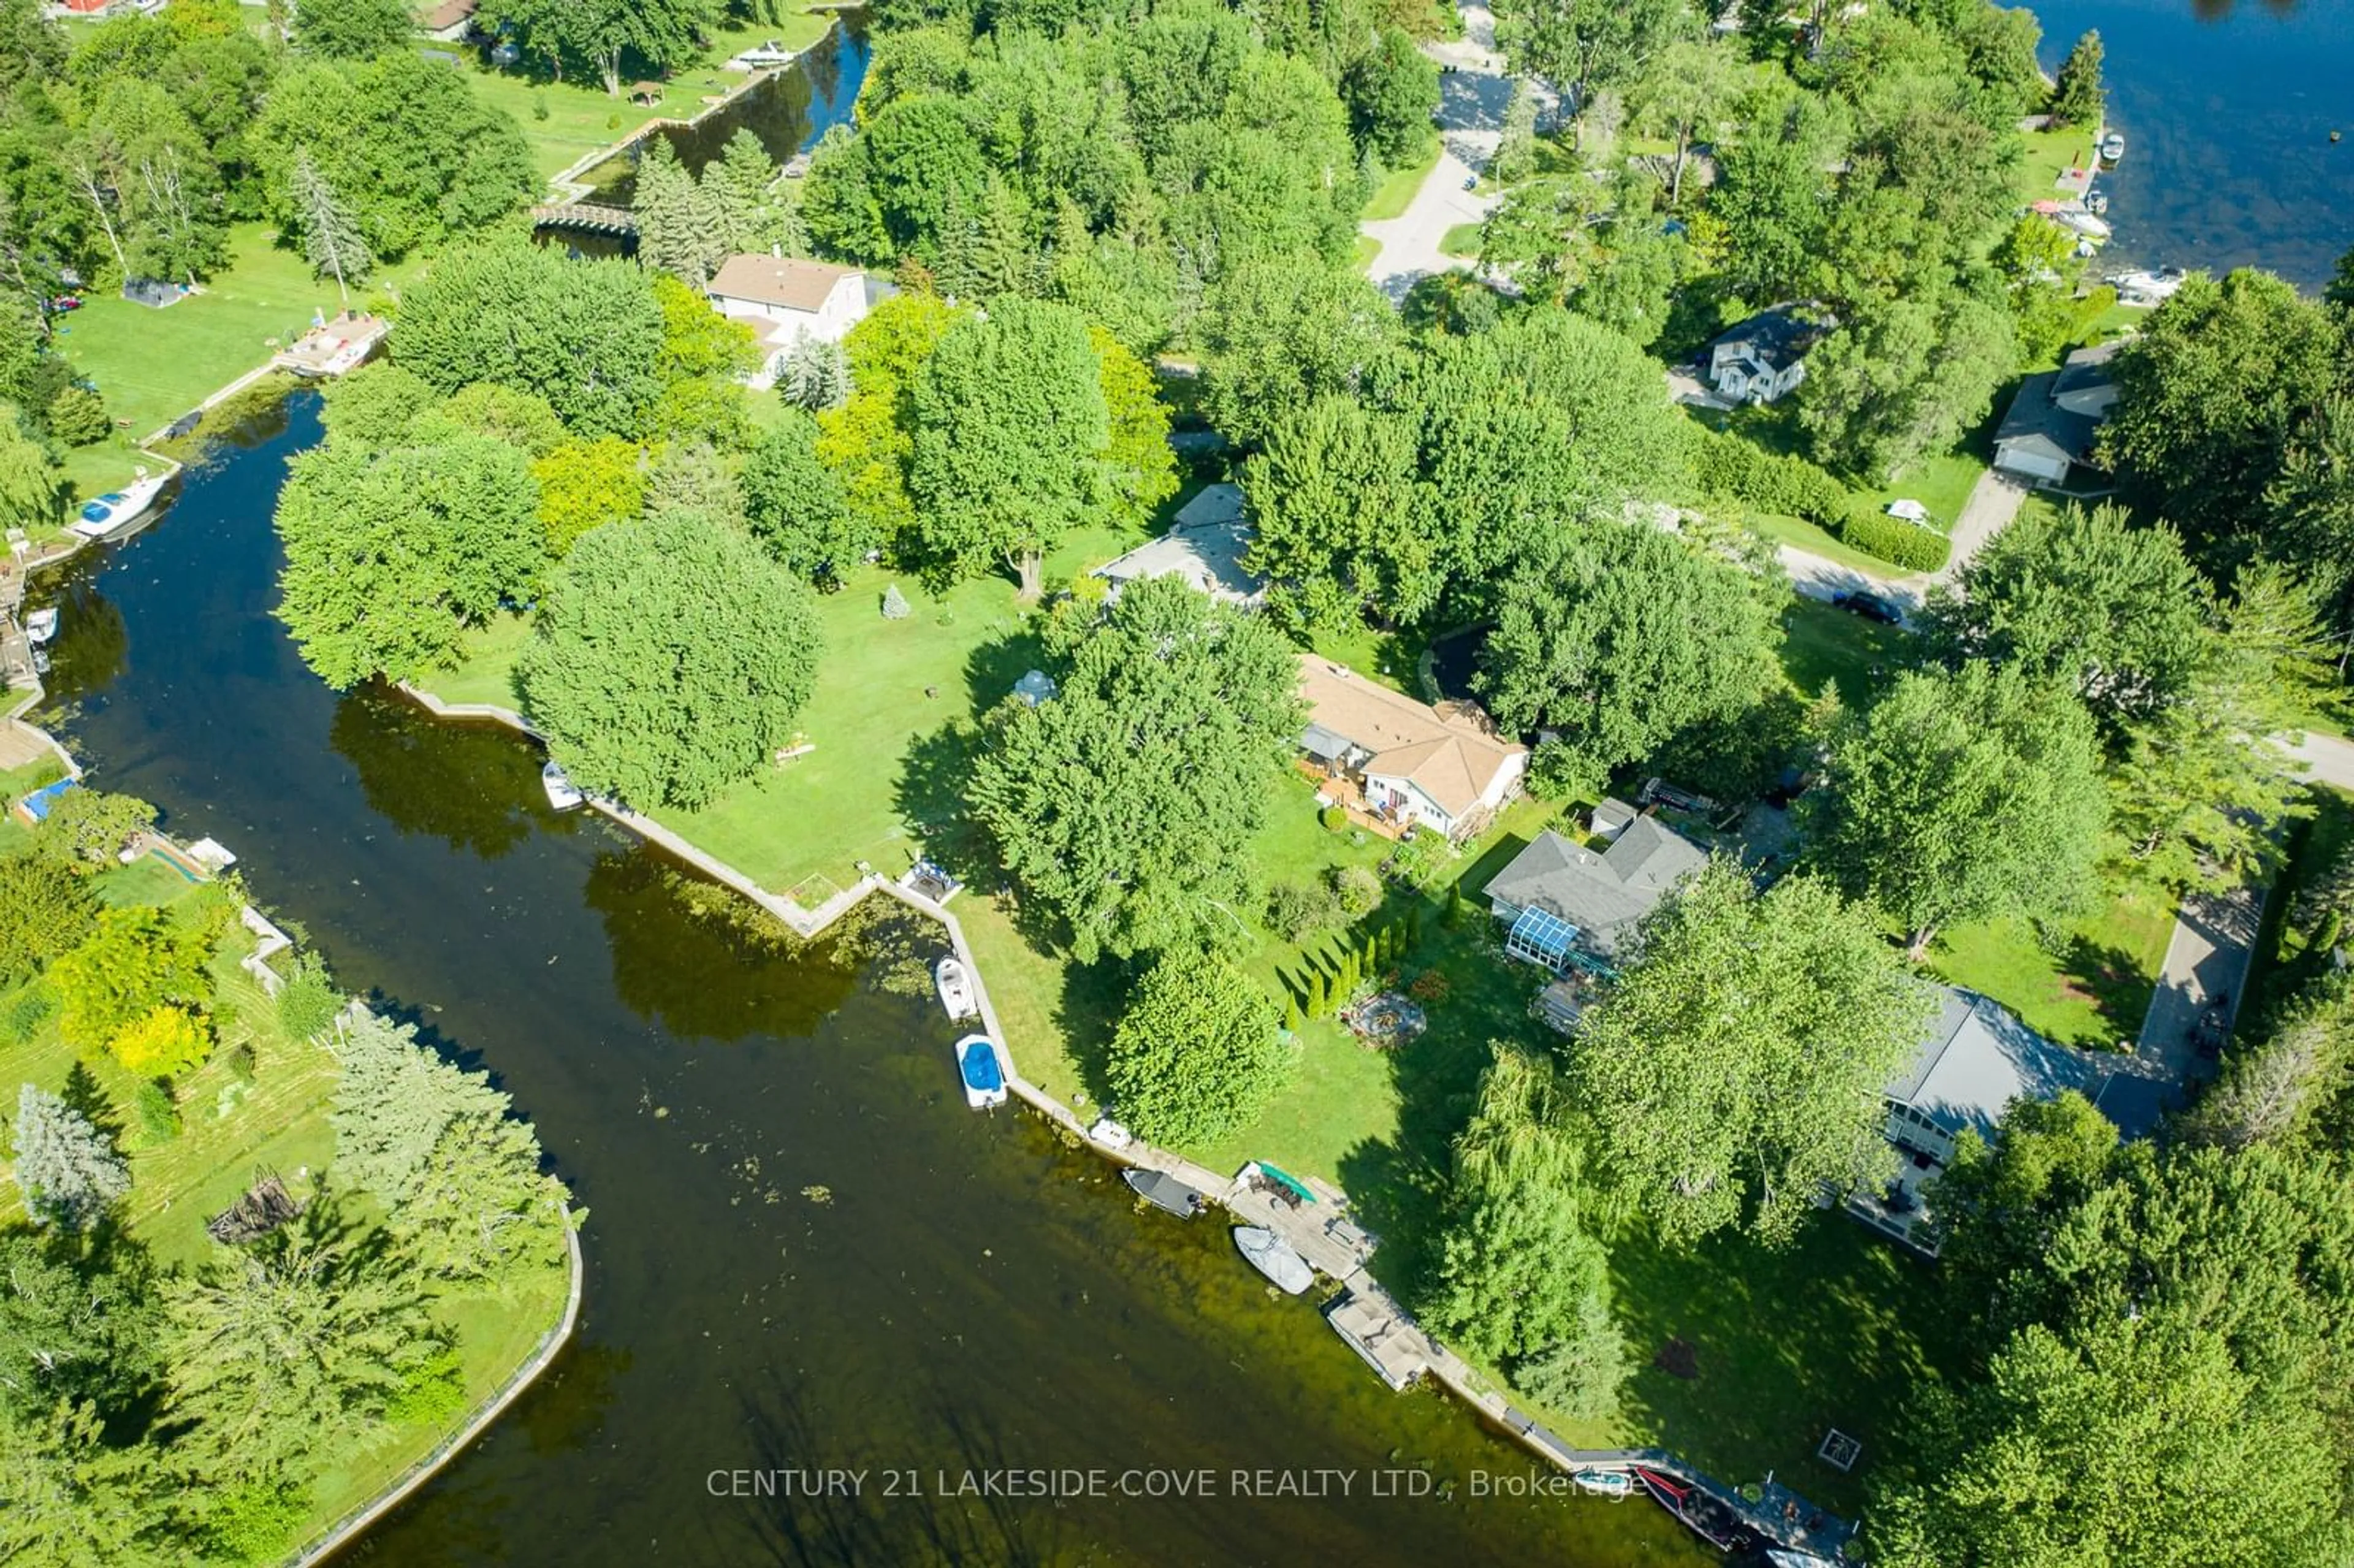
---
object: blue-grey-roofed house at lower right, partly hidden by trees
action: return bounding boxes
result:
[1846,986,2144,1257]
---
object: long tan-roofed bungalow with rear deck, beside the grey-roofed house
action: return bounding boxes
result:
[1300,655,1528,838]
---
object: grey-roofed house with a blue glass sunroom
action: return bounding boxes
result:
[1483,801,1709,975]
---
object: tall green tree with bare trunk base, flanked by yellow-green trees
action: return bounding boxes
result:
[906,299,1111,598]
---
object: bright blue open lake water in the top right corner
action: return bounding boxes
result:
[2034,0,2354,289]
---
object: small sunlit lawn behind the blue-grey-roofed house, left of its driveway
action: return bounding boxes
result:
[1930,885,2175,1050]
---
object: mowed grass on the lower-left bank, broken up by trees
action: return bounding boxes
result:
[0,810,567,1540]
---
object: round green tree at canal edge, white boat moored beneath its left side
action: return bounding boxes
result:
[516,511,819,807]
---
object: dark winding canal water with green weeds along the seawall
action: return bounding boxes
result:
[23,393,1712,1568]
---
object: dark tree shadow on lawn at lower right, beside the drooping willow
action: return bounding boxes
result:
[1610,1212,1954,1517]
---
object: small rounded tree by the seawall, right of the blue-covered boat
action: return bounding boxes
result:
[1104,951,1300,1144]
